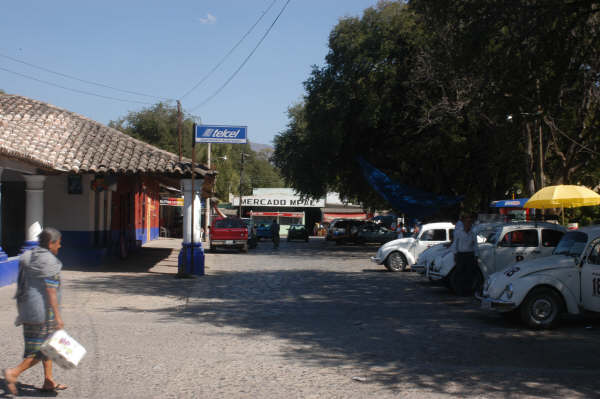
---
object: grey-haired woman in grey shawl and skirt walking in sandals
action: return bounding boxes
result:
[4,227,67,395]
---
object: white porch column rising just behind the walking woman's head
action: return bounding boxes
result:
[21,175,46,252]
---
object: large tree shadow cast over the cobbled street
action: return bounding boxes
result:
[68,262,600,397]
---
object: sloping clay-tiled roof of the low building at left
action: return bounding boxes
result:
[0,95,207,177]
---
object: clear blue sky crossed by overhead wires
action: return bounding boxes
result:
[0,0,377,144]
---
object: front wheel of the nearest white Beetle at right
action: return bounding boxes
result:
[520,287,562,329]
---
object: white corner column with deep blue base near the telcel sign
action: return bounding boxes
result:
[178,179,204,276]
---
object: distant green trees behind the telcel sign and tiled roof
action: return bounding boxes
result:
[109,103,284,202]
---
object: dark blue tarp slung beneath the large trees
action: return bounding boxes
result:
[358,158,463,218]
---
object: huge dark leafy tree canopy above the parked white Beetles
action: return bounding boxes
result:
[273,0,600,216]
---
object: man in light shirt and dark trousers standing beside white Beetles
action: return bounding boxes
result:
[450,214,479,296]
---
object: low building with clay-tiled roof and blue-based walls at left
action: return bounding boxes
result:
[0,94,213,286]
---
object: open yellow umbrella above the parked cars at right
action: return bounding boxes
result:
[523,185,600,224]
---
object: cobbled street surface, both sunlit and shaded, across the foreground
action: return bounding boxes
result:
[0,239,600,398]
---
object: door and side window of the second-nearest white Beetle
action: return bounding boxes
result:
[494,228,541,271]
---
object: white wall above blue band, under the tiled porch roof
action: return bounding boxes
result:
[44,175,94,231]
